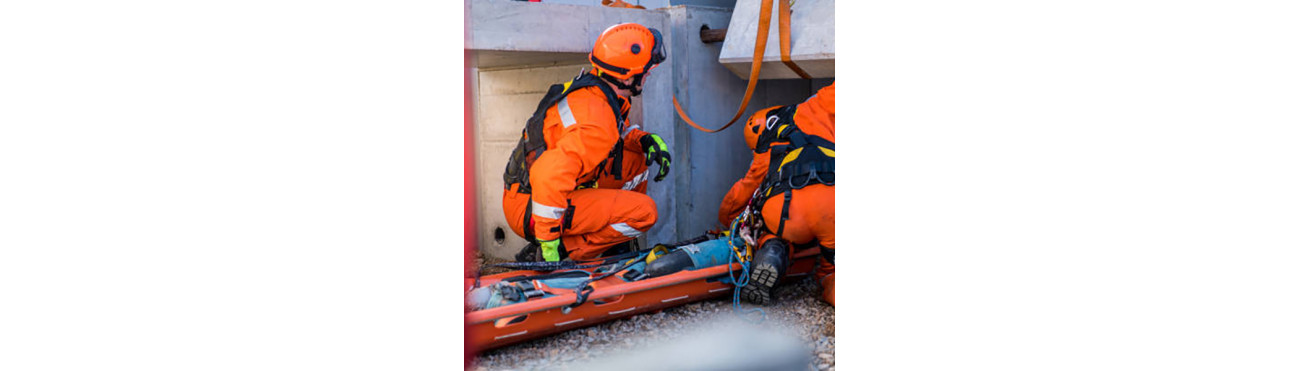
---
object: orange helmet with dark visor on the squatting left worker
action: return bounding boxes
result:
[588,23,668,79]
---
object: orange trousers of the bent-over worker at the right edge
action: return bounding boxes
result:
[759,185,835,280]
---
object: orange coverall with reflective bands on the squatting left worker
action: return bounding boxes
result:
[502,79,658,260]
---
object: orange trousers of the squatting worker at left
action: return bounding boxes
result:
[502,184,659,260]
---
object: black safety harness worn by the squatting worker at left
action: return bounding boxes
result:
[502,73,627,242]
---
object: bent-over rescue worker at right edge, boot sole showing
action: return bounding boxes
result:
[718,82,835,306]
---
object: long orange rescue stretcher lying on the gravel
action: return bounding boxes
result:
[465,234,819,351]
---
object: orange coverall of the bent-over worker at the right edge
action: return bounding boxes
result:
[718,82,835,306]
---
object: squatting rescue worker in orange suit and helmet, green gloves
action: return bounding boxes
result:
[502,23,671,262]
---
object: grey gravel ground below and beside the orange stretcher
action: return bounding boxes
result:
[471,262,835,370]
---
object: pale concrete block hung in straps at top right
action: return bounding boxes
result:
[715,0,835,79]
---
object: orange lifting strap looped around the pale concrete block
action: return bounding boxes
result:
[672,0,813,133]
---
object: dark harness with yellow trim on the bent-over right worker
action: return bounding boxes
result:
[753,104,835,236]
